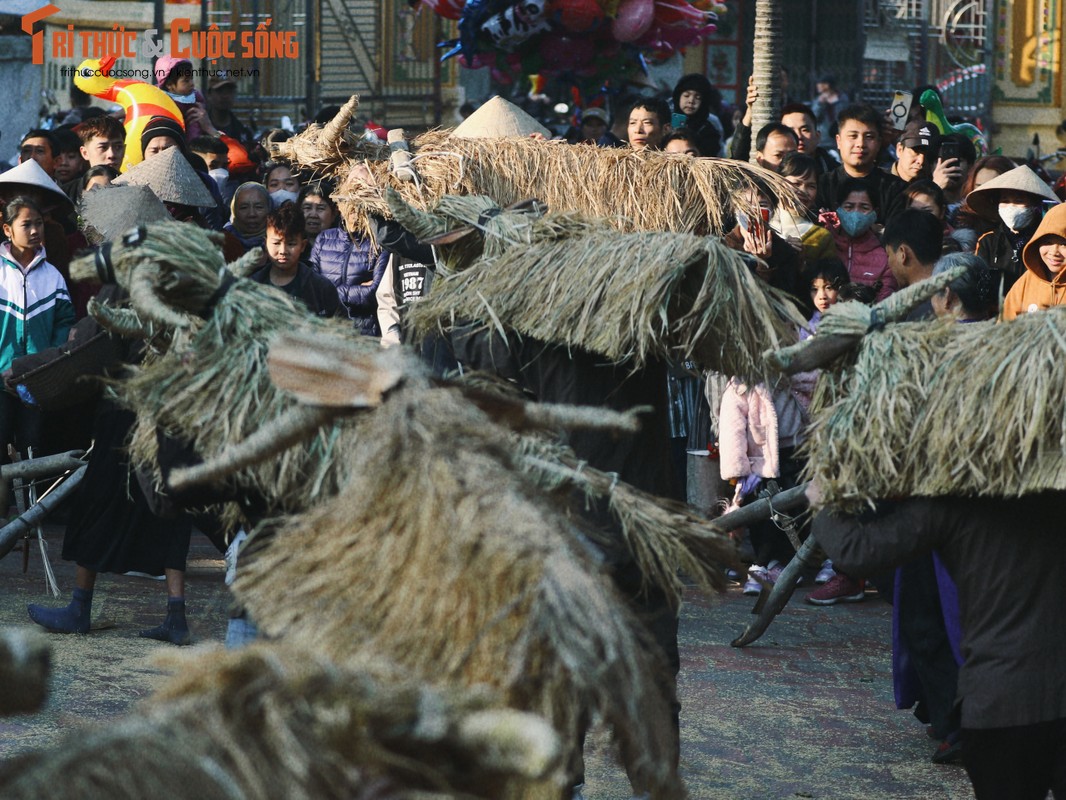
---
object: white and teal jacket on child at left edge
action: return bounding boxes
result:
[0,242,74,371]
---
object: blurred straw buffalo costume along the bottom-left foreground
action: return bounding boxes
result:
[0,645,561,800]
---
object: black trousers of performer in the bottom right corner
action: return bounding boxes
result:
[963,719,1066,800]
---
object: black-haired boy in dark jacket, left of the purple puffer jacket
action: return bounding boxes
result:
[252,203,340,317]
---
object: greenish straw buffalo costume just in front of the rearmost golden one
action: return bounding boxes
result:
[393,196,804,377]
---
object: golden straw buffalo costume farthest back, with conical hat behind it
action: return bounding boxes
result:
[272,97,794,244]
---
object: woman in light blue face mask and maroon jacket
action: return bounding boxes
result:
[820,178,898,301]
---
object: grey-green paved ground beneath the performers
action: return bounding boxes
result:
[0,526,972,800]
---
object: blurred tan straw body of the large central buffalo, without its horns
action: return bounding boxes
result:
[235,388,679,797]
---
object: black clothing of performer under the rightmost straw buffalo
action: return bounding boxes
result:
[813,493,1066,800]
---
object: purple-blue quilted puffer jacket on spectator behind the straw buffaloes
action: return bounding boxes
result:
[311,228,389,336]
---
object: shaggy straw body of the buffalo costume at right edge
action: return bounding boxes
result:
[808,308,1066,507]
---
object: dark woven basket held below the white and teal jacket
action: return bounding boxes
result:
[16,331,118,411]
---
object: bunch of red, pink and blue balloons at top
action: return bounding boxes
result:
[428,0,725,83]
